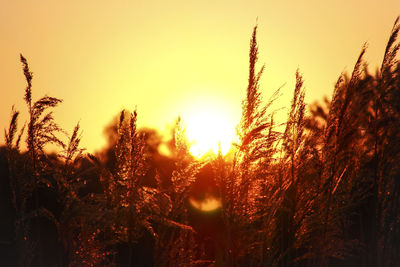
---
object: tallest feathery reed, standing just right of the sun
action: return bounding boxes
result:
[209,26,279,266]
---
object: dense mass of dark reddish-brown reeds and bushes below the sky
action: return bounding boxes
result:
[0,19,400,266]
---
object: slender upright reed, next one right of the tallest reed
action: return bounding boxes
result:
[274,71,309,266]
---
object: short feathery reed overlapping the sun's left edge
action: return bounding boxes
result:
[155,118,202,266]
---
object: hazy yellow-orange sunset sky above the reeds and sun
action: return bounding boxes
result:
[0,0,400,154]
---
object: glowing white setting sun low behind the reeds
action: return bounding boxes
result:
[184,106,235,158]
